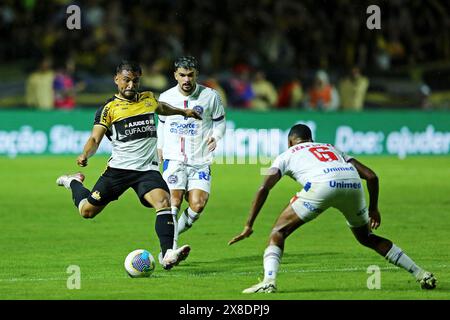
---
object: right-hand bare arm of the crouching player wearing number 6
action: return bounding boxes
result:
[349,159,381,229]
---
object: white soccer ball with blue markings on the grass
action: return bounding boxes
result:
[124,249,156,278]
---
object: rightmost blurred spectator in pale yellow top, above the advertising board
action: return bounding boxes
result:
[339,67,369,111]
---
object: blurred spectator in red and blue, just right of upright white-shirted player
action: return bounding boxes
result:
[228,64,255,108]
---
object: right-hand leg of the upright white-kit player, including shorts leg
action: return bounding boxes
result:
[178,165,211,234]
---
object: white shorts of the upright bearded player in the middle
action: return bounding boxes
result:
[163,160,211,193]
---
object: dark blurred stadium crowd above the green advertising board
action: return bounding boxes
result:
[0,0,450,110]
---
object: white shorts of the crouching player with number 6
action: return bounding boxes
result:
[291,179,369,228]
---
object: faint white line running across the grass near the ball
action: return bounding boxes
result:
[0,265,449,283]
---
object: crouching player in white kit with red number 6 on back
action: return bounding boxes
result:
[228,124,436,293]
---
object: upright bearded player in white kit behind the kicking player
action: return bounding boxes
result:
[158,56,225,252]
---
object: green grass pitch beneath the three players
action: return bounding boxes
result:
[0,156,450,300]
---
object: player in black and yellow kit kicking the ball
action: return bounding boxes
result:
[56,61,201,269]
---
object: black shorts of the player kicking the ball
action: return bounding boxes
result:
[88,167,170,208]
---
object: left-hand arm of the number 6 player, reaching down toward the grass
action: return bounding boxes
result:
[228,168,281,245]
